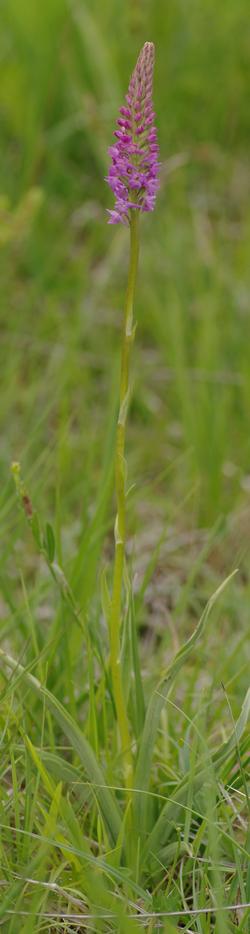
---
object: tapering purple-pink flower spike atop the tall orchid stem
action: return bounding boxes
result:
[106,42,159,224]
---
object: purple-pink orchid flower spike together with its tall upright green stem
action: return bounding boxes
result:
[107,42,159,787]
